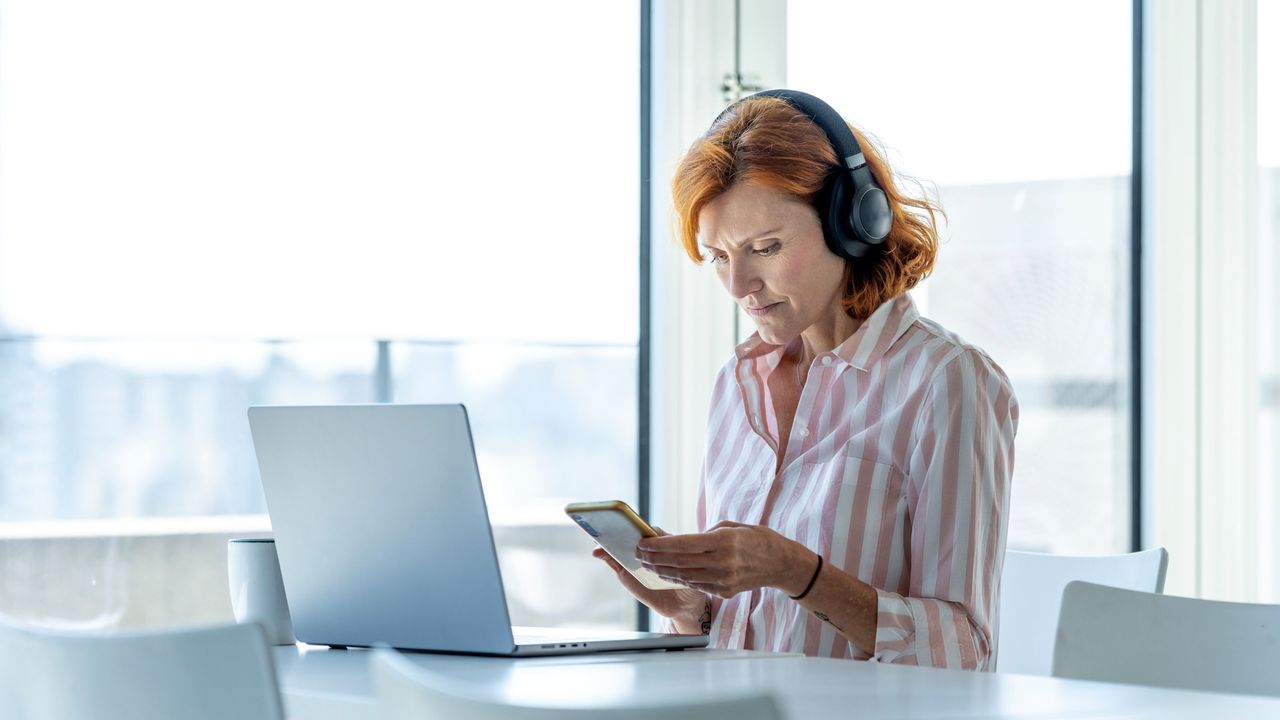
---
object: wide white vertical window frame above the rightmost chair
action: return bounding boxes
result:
[1139,0,1260,601]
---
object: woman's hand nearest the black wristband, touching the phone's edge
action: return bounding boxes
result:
[636,521,817,597]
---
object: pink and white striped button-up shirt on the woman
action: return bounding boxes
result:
[698,293,1018,670]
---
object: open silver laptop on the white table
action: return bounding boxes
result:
[248,405,708,656]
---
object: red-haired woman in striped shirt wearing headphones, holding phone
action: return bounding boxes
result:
[595,91,1018,670]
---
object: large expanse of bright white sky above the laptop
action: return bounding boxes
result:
[0,0,639,342]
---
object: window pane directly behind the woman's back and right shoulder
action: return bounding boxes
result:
[786,0,1133,553]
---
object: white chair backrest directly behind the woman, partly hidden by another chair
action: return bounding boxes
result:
[996,547,1169,675]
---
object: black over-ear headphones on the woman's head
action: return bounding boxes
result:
[740,90,893,259]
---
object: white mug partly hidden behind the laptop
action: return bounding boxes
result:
[227,538,297,644]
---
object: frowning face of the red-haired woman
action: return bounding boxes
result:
[698,183,845,345]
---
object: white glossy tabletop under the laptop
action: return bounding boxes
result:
[275,638,1280,720]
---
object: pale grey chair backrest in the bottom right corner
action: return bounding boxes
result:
[1053,583,1280,696]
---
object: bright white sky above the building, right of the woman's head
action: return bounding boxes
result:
[787,0,1133,184]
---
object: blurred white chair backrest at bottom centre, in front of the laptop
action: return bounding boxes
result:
[370,650,782,720]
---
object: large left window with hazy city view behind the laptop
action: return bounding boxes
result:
[0,0,640,625]
